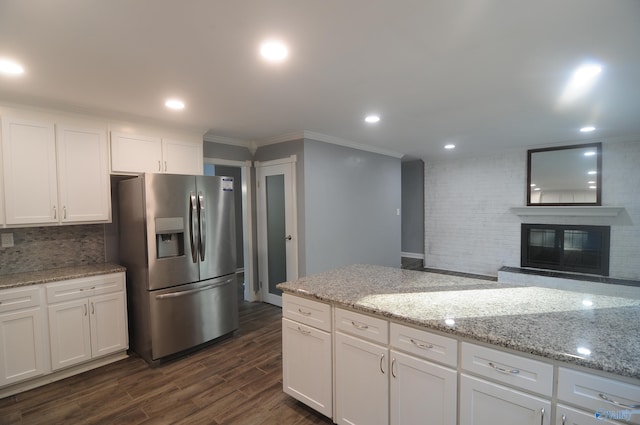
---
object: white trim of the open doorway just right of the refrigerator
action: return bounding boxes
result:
[204,157,260,301]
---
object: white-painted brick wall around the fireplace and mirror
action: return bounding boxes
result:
[425,141,640,280]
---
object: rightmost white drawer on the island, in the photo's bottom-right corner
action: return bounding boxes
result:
[558,367,640,424]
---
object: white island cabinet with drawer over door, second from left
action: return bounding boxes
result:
[334,308,389,425]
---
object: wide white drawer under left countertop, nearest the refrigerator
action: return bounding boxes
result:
[47,273,124,304]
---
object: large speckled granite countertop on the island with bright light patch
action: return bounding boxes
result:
[278,265,640,379]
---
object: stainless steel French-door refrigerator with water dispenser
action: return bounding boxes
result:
[118,174,238,364]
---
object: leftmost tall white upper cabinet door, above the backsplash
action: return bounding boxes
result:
[2,117,59,224]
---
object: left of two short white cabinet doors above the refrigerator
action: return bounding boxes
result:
[111,132,162,173]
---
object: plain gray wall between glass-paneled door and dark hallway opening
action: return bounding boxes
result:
[304,140,401,275]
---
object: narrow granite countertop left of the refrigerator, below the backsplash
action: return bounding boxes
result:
[0,263,126,289]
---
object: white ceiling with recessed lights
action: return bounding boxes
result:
[0,0,640,158]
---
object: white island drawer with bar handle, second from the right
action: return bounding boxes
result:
[462,342,553,397]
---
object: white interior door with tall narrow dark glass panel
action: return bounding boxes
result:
[256,159,298,306]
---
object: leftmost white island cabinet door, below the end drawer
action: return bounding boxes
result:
[282,319,333,417]
